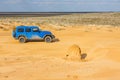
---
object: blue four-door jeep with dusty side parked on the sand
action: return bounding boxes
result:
[12,26,55,43]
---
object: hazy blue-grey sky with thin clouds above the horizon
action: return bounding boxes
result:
[0,0,120,12]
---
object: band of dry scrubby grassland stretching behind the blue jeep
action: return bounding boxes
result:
[0,12,120,30]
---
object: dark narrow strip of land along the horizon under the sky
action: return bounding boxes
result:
[0,12,116,17]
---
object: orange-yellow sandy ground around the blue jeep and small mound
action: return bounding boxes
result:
[0,26,120,80]
